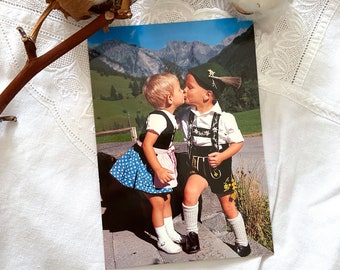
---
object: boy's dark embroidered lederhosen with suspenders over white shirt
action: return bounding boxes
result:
[188,109,237,195]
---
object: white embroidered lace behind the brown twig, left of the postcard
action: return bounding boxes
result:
[0,0,96,162]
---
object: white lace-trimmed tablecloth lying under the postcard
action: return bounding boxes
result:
[0,0,340,270]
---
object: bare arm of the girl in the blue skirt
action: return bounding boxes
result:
[142,130,174,183]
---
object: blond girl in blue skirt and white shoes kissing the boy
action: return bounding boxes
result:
[110,73,184,253]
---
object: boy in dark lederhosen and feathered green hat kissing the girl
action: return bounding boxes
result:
[179,66,251,257]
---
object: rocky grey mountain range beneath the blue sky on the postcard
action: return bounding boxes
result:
[89,29,247,77]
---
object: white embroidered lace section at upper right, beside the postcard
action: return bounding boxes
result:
[256,0,340,123]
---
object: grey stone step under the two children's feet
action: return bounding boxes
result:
[103,210,272,270]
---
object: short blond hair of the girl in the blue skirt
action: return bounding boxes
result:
[142,73,178,109]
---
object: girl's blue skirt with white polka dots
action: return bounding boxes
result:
[110,147,173,194]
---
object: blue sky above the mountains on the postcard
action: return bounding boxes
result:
[88,18,252,50]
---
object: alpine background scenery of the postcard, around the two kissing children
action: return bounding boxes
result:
[88,18,274,269]
